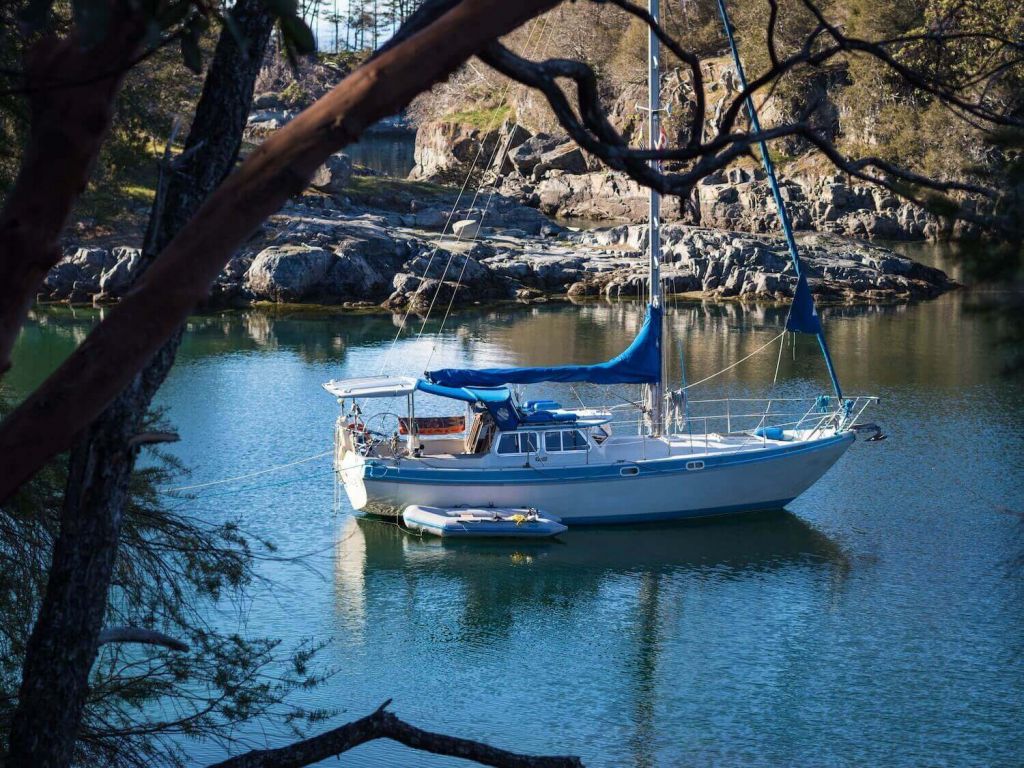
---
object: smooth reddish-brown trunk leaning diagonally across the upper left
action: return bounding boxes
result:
[0,0,559,502]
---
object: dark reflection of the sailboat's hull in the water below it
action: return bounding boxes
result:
[335,510,847,632]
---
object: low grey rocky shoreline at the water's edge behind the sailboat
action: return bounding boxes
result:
[46,169,956,313]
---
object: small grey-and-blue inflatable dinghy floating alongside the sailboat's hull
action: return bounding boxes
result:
[401,505,567,539]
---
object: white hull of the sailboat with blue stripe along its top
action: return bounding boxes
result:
[340,431,854,525]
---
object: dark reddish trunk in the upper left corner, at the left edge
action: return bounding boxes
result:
[0,2,145,374]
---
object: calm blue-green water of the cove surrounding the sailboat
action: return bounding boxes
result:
[8,286,1024,766]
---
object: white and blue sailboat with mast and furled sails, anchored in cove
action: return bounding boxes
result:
[324,0,876,526]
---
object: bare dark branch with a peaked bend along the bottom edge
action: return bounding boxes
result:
[209,699,583,768]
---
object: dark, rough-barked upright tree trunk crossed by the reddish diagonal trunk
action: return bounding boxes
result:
[6,0,273,767]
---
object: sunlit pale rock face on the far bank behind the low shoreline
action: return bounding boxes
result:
[413,123,958,240]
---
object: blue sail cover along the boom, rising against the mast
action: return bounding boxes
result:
[427,306,662,387]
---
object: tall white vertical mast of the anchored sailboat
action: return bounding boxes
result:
[647,0,665,437]
